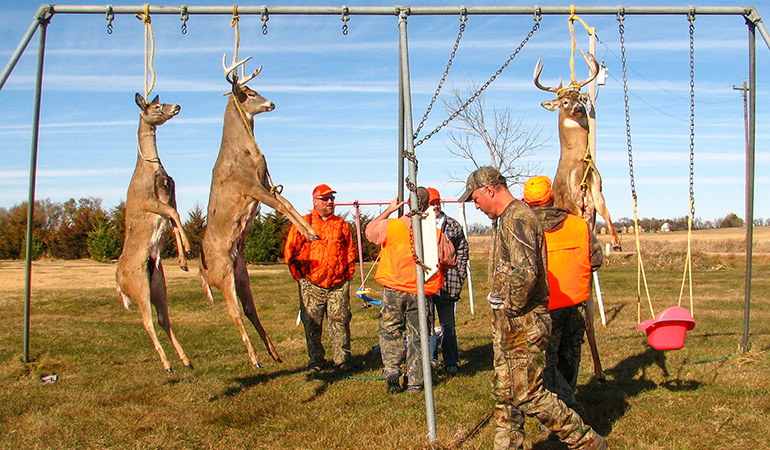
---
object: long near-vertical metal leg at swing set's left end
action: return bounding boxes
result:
[24,15,50,363]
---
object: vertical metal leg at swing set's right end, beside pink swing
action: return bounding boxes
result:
[741,20,757,352]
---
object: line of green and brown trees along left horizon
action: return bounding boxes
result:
[0,197,379,264]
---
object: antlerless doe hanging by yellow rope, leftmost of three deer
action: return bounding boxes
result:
[115,94,192,372]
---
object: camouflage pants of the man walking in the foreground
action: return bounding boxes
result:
[492,306,600,450]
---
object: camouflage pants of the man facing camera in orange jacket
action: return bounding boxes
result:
[299,278,351,367]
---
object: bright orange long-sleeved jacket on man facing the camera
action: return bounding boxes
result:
[283,210,356,288]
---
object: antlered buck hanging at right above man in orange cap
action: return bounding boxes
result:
[534,50,620,250]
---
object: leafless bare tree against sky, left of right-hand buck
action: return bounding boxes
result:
[442,83,547,183]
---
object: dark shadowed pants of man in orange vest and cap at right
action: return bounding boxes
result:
[543,303,587,420]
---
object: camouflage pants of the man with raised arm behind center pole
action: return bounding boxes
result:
[379,286,423,386]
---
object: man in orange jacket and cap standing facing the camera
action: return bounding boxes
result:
[283,184,356,374]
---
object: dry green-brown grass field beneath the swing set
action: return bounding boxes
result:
[0,228,770,450]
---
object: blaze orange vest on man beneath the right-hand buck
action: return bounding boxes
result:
[545,214,591,310]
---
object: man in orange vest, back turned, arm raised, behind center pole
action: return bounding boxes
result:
[366,187,457,393]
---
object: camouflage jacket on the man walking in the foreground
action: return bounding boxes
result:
[489,199,548,317]
